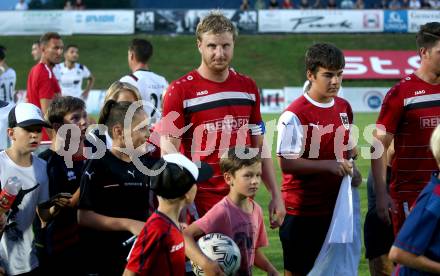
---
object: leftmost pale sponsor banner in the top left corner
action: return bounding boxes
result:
[0,10,73,35]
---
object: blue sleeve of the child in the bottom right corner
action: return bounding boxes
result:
[394,191,440,256]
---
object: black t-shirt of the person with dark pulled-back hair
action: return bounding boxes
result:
[79,150,154,275]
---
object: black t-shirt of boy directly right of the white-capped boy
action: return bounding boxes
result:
[39,149,86,254]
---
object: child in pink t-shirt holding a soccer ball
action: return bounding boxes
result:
[183,148,278,275]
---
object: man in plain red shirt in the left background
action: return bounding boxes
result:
[27,32,64,141]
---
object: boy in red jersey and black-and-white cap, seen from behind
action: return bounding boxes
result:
[124,153,212,276]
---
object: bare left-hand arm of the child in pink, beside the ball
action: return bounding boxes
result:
[183,223,224,275]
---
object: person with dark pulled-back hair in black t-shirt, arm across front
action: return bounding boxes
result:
[78,100,153,275]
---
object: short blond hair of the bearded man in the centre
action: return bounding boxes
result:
[196,10,238,41]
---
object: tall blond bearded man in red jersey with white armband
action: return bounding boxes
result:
[159,12,285,227]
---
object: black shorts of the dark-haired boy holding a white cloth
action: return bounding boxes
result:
[280,215,332,275]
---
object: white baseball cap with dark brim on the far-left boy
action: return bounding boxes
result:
[8,103,52,128]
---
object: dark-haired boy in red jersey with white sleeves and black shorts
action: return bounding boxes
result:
[277,44,359,275]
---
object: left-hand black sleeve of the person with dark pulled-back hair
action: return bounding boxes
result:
[78,159,102,210]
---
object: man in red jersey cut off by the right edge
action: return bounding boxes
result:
[371,22,440,234]
